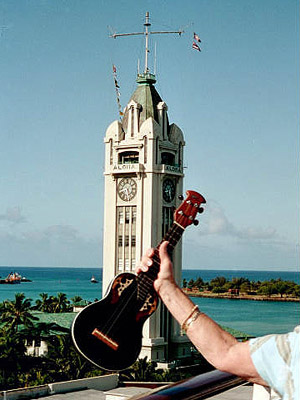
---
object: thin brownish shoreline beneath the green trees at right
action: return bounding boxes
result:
[182,289,300,303]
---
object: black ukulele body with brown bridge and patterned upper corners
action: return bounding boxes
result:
[72,273,158,371]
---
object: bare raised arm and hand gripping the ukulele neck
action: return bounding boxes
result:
[137,242,267,385]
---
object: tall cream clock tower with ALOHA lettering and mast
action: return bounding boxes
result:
[103,13,191,363]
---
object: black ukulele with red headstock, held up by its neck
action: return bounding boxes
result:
[71,190,205,371]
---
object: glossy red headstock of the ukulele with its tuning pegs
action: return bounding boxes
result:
[174,190,206,228]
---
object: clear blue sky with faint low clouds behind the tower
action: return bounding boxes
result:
[0,0,299,270]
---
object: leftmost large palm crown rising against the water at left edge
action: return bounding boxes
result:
[0,293,38,333]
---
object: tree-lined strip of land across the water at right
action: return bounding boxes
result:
[182,276,300,302]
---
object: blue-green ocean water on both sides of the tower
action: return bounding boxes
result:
[0,267,300,336]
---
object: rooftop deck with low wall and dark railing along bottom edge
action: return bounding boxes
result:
[0,371,253,400]
